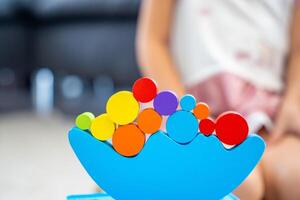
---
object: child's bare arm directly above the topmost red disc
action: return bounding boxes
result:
[137,0,184,96]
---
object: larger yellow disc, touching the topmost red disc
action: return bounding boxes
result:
[106,91,140,125]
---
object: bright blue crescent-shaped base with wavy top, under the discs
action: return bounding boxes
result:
[69,128,265,200]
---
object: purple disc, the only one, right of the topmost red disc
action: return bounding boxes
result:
[153,91,178,115]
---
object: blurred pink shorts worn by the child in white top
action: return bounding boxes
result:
[188,73,281,131]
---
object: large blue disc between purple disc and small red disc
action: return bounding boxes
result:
[166,110,198,144]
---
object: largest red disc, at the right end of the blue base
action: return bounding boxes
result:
[216,112,249,145]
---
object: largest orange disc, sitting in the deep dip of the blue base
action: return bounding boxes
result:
[112,124,146,156]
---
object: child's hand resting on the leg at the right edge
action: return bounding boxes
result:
[271,94,300,141]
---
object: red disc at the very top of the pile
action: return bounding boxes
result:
[132,77,157,103]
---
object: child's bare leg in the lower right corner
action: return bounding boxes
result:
[263,134,300,200]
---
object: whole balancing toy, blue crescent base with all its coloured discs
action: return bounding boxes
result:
[68,77,265,200]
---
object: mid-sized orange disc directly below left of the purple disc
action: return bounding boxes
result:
[137,108,162,134]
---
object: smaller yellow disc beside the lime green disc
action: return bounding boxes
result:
[90,113,116,141]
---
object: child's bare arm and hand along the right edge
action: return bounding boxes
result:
[272,4,300,140]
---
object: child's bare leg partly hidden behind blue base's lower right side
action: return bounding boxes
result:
[234,165,265,200]
